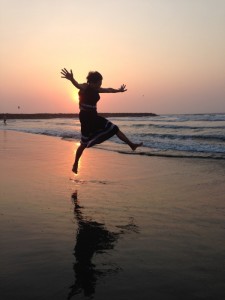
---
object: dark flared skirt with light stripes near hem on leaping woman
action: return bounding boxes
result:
[79,110,119,148]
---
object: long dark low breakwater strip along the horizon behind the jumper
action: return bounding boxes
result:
[0,113,157,119]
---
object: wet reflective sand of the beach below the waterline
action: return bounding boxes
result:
[0,130,225,300]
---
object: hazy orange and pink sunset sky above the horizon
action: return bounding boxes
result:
[0,0,225,114]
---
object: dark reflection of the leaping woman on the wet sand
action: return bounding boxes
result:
[68,192,120,299]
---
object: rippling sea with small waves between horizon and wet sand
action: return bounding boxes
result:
[0,114,225,159]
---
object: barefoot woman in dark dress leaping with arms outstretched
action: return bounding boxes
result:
[61,68,143,174]
